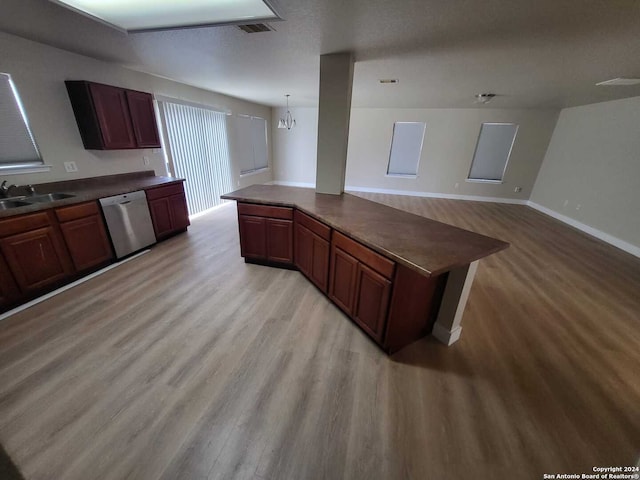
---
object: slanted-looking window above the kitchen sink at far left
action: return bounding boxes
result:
[0,73,48,174]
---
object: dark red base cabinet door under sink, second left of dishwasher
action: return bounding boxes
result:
[0,227,72,293]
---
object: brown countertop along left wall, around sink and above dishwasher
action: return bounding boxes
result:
[0,171,184,218]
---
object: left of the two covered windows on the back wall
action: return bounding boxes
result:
[387,122,426,177]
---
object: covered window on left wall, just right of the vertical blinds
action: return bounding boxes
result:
[236,115,269,175]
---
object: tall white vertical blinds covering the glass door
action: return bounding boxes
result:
[161,101,233,215]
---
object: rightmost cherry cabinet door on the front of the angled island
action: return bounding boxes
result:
[353,263,391,341]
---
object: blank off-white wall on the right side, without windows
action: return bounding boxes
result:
[531,97,640,248]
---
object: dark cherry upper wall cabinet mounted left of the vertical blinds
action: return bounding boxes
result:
[65,81,160,150]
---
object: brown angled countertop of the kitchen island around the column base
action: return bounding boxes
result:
[222,185,509,276]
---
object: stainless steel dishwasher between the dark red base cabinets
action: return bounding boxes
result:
[100,190,156,258]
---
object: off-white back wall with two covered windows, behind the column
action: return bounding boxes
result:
[274,108,558,201]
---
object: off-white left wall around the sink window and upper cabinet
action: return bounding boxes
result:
[0,32,272,186]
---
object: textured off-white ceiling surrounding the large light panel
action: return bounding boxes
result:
[0,0,640,108]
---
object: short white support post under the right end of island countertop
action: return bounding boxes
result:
[432,260,478,345]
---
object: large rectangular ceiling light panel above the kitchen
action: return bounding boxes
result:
[50,0,281,32]
